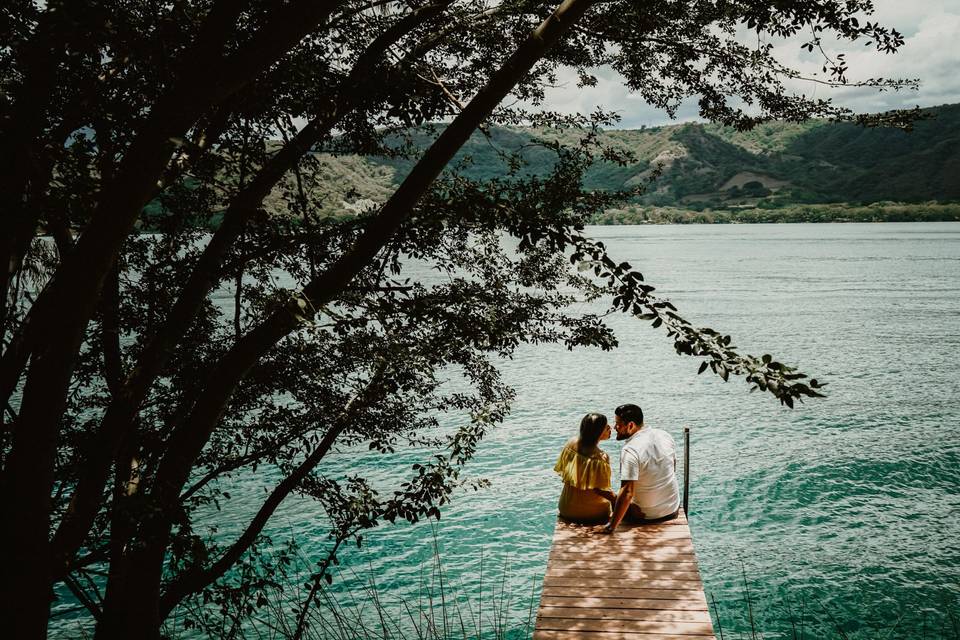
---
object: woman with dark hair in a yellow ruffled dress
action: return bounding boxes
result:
[553,413,614,524]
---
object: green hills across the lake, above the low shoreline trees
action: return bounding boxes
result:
[298,105,960,221]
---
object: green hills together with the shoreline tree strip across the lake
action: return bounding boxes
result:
[148,105,960,226]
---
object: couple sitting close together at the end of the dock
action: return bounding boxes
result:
[554,404,680,533]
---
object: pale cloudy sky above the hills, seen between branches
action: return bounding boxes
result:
[532,0,960,129]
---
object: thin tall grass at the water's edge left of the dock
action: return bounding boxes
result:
[167,532,542,640]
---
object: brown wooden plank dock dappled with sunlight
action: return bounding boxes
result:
[533,511,715,640]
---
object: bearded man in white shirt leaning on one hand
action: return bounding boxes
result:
[605,404,680,533]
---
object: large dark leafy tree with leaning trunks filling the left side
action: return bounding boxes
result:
[0,0,911,637]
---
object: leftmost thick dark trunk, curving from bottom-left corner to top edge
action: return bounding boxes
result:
[0,0,339,638]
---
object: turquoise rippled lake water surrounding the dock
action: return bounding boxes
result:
[50,223,960,639]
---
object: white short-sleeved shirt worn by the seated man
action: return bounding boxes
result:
[620,427,680,520]
